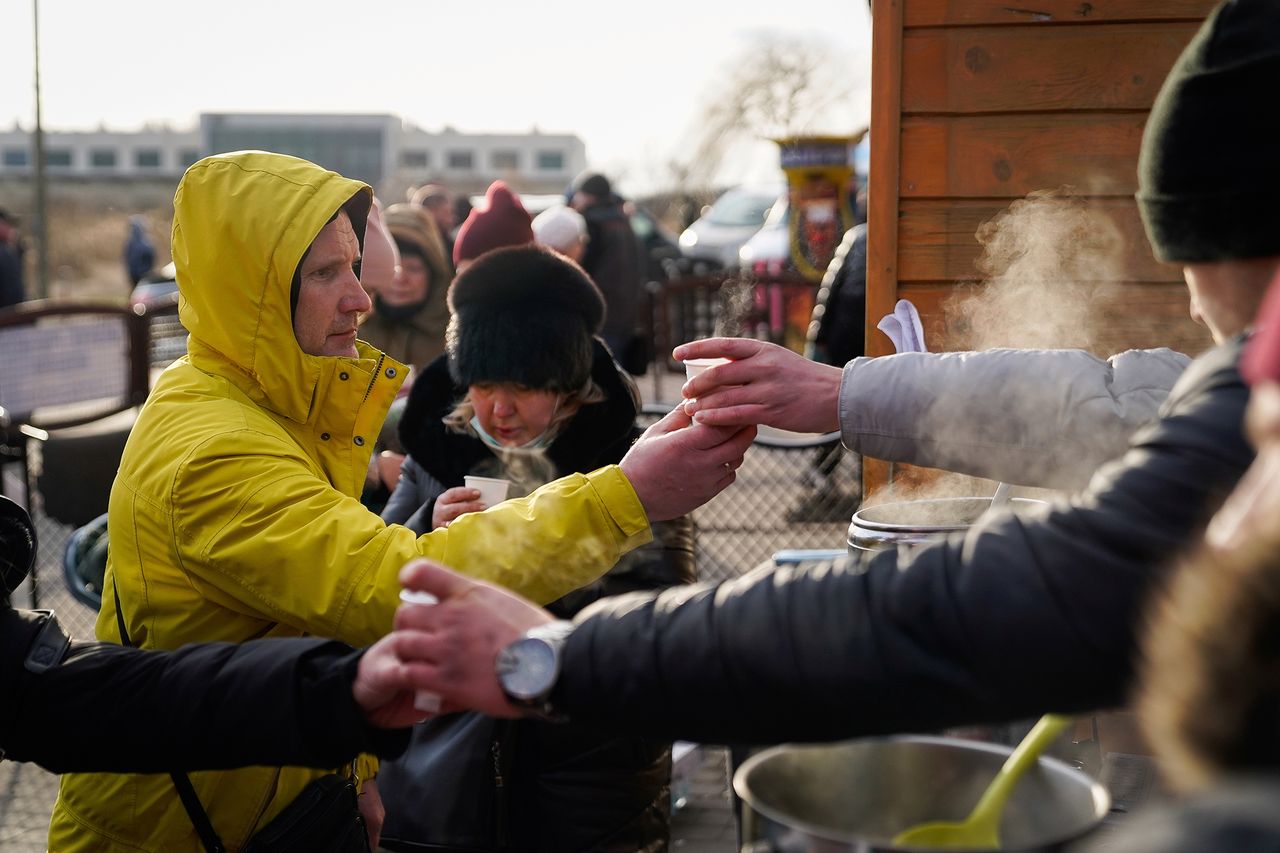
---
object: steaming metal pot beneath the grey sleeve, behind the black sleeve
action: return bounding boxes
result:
[849,497,1044,553]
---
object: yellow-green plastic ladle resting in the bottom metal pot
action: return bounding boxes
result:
[892,713,1071,850]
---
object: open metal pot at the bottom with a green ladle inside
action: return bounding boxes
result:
[733,735,1111,853]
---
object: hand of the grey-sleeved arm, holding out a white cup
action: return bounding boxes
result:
[672,338,844,433]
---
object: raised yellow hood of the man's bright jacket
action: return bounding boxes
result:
[173,151,376,423]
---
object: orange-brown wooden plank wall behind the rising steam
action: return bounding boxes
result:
[867,0,1215,485]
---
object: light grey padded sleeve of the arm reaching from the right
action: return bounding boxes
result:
[840,348,1190,489]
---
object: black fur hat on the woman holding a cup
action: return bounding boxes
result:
[445,240,604,392]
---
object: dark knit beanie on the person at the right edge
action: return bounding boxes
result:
[1138,0,1280,263]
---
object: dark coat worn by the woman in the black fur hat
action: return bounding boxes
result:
[379,342,695,853]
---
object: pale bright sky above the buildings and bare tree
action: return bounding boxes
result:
[0,0,870,193]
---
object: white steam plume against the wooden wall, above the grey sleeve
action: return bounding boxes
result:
[943,190,1124,350]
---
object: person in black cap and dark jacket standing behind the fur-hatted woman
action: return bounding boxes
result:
[570,172,648,375]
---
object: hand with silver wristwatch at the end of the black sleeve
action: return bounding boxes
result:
[384,560,553,717]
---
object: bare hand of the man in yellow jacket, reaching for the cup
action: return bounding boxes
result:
[618,406,755,521]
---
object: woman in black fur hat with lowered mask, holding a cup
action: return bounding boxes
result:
[379,246,695,850]
